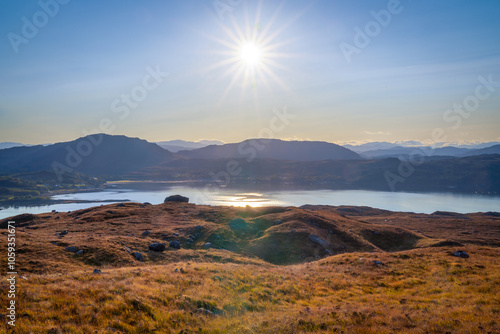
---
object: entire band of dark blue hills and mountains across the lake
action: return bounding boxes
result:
[0,134,500,194]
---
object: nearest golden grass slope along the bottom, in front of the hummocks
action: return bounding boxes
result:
[0,246,500,333]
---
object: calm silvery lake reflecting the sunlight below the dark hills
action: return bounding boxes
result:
[0,183,500,218]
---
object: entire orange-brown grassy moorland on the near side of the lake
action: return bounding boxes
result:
[0,203,500,333]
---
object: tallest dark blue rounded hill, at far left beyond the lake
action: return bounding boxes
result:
[0,134,173,176]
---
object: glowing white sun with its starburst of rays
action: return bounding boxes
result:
[199,1,297,105]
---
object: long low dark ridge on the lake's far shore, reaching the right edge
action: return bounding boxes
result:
[139,155,500,195]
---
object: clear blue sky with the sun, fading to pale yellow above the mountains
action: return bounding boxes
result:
[0,0,500,144]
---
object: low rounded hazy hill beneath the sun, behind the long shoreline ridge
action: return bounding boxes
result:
[179,139,362,161]
